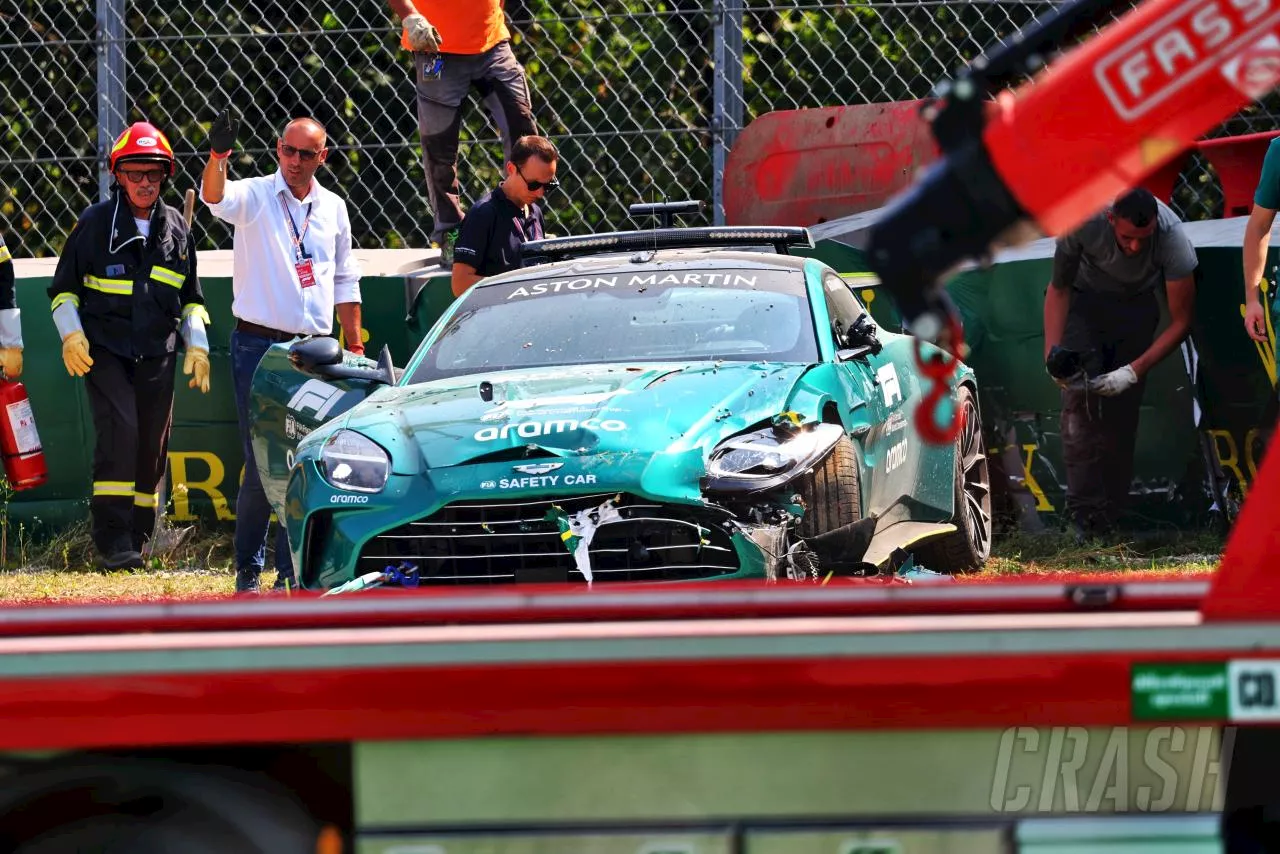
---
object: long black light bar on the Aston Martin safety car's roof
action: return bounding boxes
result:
[522,225,813,262]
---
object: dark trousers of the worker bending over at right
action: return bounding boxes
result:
[1060,380,1146,534]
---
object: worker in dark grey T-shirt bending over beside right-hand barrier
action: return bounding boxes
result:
[1044,189,1197,535]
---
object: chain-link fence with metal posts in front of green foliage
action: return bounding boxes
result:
[0,0,1280,256]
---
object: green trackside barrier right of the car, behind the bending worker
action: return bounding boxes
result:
[810,218,1280,530]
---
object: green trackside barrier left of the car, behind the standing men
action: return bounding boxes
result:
[0,250,453,538]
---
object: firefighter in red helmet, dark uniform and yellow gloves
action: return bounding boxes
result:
[46,122,209,570]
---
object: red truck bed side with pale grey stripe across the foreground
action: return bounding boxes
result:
[0,430,1280,749]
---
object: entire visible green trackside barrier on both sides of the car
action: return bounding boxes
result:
[4,218,1280,545]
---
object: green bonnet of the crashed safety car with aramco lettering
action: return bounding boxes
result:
[346,362,809,467]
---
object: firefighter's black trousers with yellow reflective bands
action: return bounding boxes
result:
[86,346,177,557]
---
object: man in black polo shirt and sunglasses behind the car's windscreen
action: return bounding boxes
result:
[453,136,559,297]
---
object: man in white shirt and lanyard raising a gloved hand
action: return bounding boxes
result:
[200,110,365,593]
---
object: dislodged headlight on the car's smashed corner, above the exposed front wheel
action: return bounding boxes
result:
[707,424,845,492]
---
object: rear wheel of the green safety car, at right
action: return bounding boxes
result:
[911,385,992,572]
